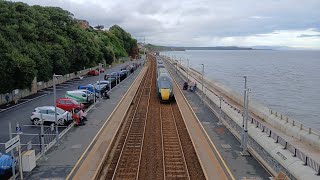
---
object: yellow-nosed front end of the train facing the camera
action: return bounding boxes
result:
[157,75,173,102]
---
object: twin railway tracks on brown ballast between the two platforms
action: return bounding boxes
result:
[94,56,205,179]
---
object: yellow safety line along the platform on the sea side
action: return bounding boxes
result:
[165,57,235,180]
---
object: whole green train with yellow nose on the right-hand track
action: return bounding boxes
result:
[156,56,174,102]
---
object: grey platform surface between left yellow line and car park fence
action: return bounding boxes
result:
[24,64,141,179]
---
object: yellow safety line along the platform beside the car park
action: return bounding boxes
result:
[66,67,143,179]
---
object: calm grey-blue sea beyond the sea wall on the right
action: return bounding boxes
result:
[160,50,320,130]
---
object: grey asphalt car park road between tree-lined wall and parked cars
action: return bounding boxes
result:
[0,61,140,152]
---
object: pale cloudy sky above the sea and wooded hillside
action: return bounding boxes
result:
[14,0,320,49]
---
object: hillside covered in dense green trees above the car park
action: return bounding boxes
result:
[0,0,138,93]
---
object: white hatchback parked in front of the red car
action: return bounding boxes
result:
[30,106,72,125]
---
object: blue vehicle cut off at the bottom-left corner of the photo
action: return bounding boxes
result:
[0,153,17,179]
